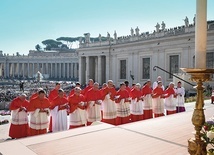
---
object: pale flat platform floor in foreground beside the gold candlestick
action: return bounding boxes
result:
[0,100,214,155]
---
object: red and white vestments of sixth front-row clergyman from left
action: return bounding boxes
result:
[102,87,117,125]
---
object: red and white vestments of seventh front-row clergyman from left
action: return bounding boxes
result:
[115,89,130,125]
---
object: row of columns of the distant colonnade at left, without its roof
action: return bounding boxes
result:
[0,61,79,79]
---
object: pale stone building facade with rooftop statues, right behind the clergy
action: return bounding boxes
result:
[78,21,214,86]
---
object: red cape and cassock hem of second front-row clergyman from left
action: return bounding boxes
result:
[28,96,50,136]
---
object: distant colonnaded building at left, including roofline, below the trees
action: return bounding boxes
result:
[0,51,79,81]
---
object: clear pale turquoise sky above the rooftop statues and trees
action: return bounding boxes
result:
[0,0,214,54]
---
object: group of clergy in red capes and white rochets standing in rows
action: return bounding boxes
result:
[9,76,185,139]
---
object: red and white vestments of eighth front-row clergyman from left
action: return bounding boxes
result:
[129,89,144,122]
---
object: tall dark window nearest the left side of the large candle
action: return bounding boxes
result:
[169,55,179,78]
